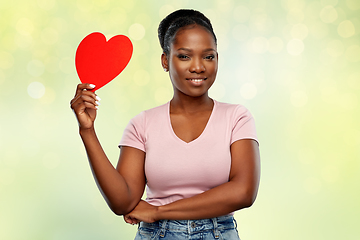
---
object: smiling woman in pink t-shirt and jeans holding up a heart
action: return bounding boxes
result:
[71,10,260,239]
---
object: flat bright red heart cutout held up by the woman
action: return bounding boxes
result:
[75,32,133,92]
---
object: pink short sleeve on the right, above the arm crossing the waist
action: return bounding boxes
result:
[230,105,259,144]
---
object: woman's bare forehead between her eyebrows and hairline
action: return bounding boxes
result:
[171,25,216,49]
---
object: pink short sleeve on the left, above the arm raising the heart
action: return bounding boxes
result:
[119,112,146,152]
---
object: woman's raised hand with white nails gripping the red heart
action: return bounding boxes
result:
[70,83,100,130]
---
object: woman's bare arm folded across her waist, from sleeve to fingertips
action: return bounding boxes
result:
[125,139,260,223]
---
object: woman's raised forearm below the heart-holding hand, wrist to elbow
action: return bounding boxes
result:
[79,128,137,215]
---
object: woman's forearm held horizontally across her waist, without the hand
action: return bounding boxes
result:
[156,181,256,220]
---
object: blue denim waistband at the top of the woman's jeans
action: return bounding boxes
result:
[139,215,237,237]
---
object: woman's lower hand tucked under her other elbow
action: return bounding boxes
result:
[124,200,158,224]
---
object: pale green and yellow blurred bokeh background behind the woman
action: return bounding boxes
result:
[0,0,360,240]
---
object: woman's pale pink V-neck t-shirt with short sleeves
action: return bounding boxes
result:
[119,100,257,206]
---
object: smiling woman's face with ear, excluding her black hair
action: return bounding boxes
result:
[162,25,218,97]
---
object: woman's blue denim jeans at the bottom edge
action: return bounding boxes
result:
[135,215,240,240]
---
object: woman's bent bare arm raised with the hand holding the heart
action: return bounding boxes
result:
[71,84,145,215]
